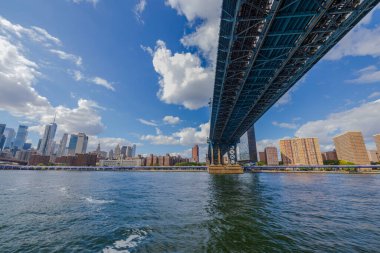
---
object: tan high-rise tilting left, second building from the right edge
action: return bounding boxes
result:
[333,131,370,165]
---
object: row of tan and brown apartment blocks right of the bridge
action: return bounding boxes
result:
[252,131,380,165]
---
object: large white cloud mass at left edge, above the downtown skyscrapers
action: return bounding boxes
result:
[0,33,104,138]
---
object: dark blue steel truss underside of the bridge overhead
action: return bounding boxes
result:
[209,0,379,168]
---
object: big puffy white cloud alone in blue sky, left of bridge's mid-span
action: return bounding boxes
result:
[153,41,214,110]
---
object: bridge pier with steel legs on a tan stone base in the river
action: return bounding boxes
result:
[208,143,244,174]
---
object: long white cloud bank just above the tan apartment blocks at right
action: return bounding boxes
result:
[295,99,380,150]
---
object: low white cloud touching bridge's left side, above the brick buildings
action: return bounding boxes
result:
[141,123,210,146]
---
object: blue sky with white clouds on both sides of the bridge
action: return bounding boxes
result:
[0,0,380,158]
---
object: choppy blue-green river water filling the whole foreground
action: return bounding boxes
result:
[0,171,380,252]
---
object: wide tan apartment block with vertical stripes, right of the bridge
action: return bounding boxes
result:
[280,138,323,165]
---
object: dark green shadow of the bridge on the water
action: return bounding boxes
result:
[204,174,289,252]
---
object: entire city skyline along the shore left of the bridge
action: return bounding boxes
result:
[0,120,199,166]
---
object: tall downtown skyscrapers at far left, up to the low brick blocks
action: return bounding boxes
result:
[0,120,140,166]
